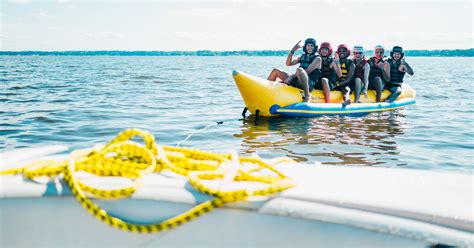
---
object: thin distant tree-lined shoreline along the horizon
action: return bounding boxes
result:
[0,48,474,57]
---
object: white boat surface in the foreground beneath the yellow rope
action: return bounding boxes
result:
[0,147,474,247]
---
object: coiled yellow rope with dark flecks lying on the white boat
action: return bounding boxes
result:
[0,129,294,233]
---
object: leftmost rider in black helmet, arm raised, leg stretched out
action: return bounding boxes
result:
[267,38,321,102]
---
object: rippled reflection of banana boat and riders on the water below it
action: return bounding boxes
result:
[234,110,407,166]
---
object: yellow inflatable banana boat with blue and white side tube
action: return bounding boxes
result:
[232,71,416,116]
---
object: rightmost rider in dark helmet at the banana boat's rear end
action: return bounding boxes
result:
[385,46,414,102]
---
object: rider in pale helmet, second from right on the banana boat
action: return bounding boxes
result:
[369,45,390,102]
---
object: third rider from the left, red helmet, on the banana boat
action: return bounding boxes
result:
[334,44,355,106]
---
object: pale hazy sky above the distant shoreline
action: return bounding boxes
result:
[0,0,474,51]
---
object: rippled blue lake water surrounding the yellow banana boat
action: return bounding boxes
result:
[0,56,474,172]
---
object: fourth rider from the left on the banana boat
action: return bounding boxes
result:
[349,46,370,103]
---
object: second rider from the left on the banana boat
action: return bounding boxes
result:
[315,42,341,103]
